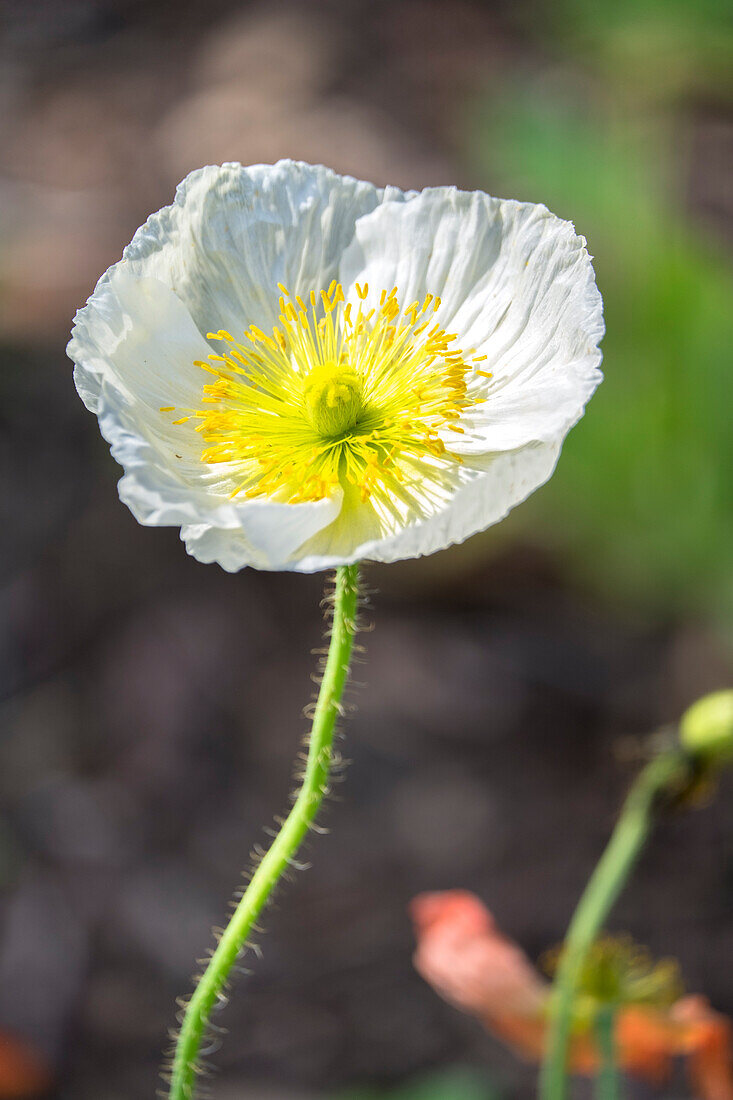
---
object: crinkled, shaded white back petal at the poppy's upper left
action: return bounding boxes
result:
[117,161,411,333]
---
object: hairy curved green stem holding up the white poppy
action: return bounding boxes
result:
[168,565,359,1100]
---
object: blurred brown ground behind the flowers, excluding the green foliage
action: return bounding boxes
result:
[0,0,733,1100]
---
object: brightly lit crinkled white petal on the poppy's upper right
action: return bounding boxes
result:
[340,188,603,454]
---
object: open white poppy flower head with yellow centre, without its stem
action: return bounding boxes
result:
[68,161,603,572]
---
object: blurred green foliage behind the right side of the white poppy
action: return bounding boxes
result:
[473,0,733,627]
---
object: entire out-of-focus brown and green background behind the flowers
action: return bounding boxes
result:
[0,0,733,1100]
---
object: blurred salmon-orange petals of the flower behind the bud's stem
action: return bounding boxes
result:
[411,890,733,1100]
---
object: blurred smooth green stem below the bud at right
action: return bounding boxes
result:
[539,749,694,1100]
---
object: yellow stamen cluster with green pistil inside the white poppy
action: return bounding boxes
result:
[166,282,490,516]
